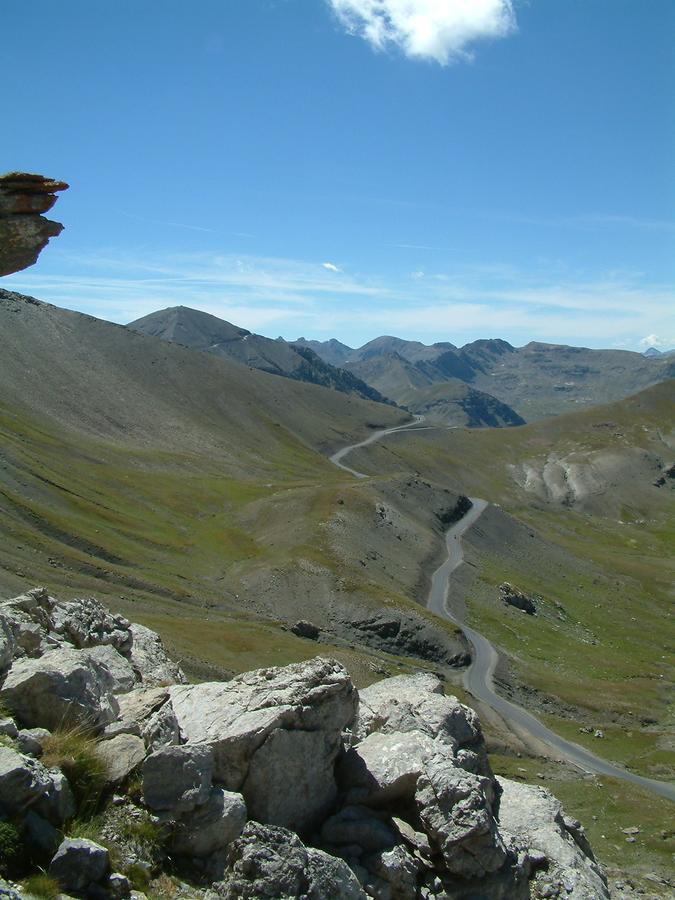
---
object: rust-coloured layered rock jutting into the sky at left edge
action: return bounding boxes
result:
[0,172,68,275]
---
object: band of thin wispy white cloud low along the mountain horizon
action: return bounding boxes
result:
[2,248,675,349]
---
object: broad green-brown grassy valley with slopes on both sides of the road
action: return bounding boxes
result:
[0,284,674,896]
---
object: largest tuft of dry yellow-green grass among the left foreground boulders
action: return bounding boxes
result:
[40,727,107,818]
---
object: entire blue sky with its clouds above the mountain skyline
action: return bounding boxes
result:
[0,0,675,349]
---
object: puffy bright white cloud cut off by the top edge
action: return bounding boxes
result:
[328,0,516,66]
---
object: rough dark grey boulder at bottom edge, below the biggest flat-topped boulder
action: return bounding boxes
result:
[206,822,366,900]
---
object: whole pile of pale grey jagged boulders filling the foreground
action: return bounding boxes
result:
[0,588,609,900]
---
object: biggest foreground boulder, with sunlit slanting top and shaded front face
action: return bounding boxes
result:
[170,657,358,830]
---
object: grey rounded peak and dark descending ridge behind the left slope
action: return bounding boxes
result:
[127,306,387,403]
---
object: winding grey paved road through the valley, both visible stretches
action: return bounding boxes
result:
[330,416,675,801]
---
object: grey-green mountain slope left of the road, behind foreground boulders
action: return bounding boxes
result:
[0,291,465,671]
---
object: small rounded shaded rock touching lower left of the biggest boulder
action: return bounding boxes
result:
[172,788,246,859]
